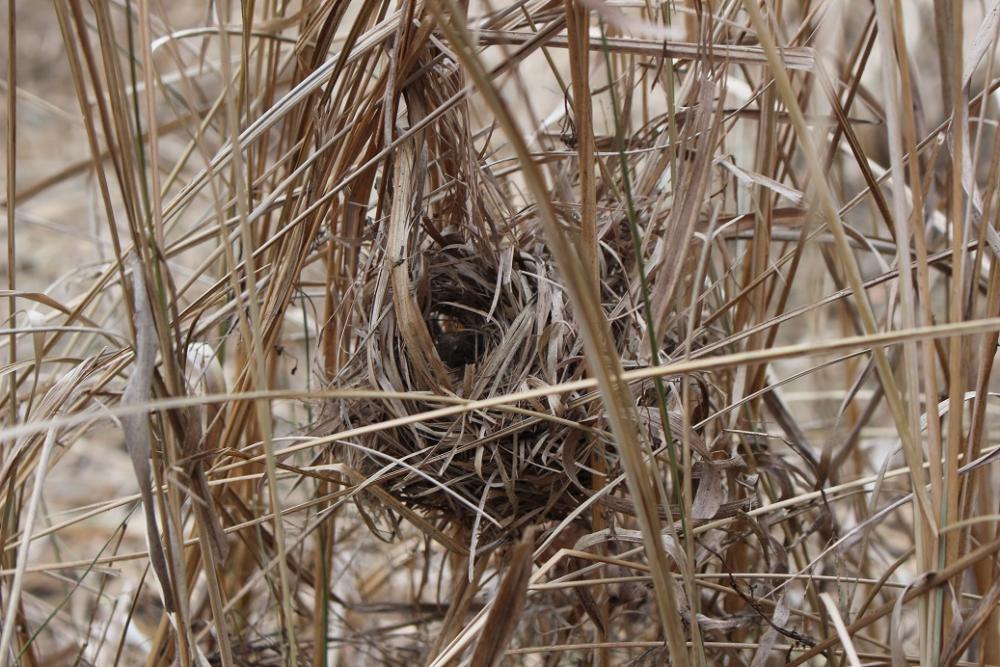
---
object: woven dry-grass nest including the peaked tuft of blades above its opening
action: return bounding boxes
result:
[320,62,728,539]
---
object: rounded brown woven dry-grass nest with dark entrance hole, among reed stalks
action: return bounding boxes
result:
[324,170,724,539]
